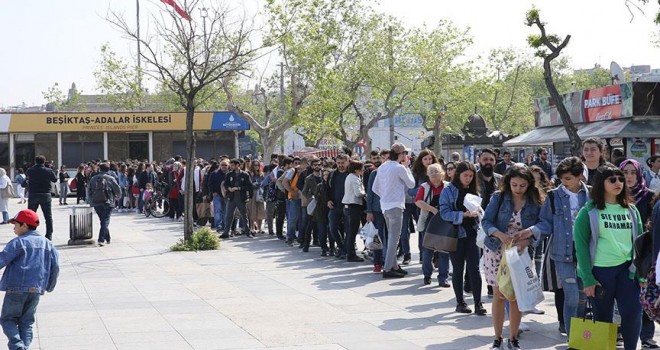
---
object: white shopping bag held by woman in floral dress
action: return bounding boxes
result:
[504,246,544,312]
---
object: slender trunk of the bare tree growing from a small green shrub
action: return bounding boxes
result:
[183,106,197,242]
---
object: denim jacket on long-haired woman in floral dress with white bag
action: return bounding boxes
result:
[481,191,541,246]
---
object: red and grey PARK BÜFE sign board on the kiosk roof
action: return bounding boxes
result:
[534,83,633,127]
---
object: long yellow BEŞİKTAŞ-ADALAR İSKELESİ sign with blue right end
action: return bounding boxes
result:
[9,112,249,132]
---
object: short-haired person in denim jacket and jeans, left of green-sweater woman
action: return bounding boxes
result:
[536,157,589,334]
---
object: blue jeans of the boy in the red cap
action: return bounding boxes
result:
[0,292,40,350]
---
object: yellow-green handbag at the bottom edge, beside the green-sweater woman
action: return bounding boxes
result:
[568,298,617,350]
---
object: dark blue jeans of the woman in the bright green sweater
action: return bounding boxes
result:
[593,262,642,350]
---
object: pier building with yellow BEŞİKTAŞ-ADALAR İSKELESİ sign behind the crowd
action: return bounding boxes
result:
[0,112,250,177]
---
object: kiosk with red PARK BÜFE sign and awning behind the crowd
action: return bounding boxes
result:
[504,82,660,170]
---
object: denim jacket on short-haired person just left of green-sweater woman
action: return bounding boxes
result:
[536,183,589,262]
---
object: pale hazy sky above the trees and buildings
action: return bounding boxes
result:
[0,0,660,107]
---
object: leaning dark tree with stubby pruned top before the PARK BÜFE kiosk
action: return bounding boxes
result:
[526,8,582,156]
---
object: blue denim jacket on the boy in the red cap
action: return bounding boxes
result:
[0,231,60,294]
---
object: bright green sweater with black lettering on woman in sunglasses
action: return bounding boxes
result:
[573,201,643,287]
